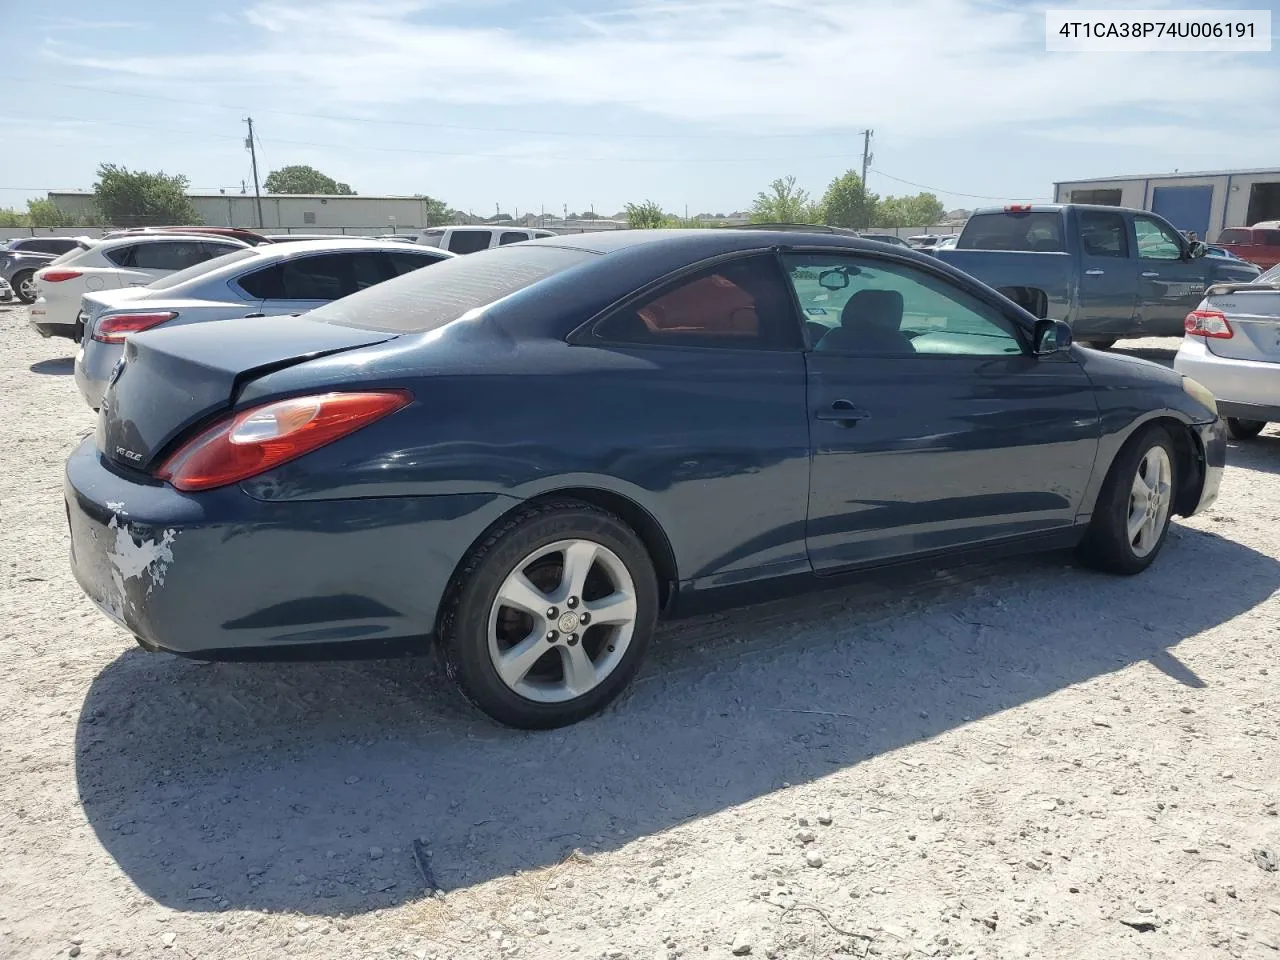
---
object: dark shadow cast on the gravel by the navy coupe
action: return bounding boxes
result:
[76,526,1280,915]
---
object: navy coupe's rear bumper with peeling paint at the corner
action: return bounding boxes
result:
[65,438,515,659]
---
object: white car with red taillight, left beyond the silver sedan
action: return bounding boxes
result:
[29,232,248,340]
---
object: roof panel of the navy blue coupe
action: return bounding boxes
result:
[529,227,884,259]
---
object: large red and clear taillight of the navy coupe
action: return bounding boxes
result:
[156,390,413,492]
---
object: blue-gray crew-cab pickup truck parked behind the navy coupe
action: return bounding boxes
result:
[934,204,1261,348]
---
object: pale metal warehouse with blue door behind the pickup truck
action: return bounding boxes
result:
[1053,170,1280,242]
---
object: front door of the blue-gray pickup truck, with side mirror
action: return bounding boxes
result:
[1133,214,1210,337]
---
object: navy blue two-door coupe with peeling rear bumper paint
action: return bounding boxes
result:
[67,230,1225,727]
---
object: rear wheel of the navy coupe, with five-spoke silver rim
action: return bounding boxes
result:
[439,502,658,730]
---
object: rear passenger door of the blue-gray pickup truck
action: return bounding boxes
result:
[1071,209,1138,340]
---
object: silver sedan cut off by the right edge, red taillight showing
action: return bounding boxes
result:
[1174,265,1280,440]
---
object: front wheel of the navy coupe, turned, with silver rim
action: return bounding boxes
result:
[1076,426,1178,576]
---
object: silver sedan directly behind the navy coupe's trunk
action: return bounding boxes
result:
[76,237,456,410]
